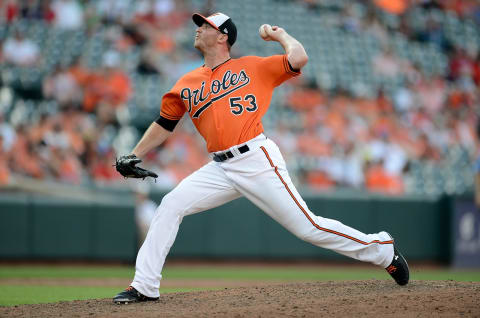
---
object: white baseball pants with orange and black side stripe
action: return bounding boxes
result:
[131,134,393,297]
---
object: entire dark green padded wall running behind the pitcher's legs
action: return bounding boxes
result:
[0,193,466,262]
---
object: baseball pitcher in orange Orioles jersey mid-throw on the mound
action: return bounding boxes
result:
[113,13,409,303]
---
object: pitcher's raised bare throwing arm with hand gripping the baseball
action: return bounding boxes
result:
[259,24,308,71]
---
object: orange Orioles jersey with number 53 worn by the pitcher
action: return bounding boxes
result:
[160,55,300,152]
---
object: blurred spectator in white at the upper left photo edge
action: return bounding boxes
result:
[3,30,40,66]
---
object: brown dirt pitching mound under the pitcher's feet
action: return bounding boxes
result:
[0,280,480,318]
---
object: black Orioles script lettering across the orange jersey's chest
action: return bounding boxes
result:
[180,70,250,118]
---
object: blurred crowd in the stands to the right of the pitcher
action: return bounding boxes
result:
[276,0,480,194]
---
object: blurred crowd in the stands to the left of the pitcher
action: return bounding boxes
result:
[0,0,207,187]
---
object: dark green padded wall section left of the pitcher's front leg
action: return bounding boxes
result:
[0,195,137,261]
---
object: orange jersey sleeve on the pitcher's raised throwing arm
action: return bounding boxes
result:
[258,54,301,87]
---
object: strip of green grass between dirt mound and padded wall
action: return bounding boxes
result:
[0,265,480,306]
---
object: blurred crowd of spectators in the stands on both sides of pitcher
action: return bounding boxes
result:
[0,0,480,194]
